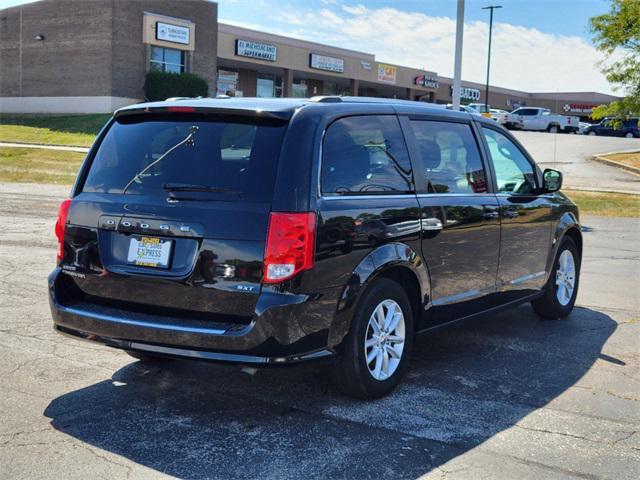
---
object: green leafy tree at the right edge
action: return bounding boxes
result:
[590,0,640,120]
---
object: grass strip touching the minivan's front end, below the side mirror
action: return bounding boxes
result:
[563,190,640,217]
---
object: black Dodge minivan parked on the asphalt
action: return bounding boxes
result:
[49,97,582,398]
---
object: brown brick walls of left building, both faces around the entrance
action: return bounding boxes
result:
[0,0,217,99]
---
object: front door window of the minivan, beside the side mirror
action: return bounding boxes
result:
[482,127,536,195]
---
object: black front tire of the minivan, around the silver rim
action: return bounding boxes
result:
[531,237,580,320]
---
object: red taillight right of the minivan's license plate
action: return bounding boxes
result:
[263,212,316,283]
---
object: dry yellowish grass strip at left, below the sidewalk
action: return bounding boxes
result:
[0,148,85,185]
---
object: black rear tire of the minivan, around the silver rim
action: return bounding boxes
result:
[332,278,414,399]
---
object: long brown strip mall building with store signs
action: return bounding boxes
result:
[0,0,616,118]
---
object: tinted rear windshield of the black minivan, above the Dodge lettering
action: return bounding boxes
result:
[83,115,286,203]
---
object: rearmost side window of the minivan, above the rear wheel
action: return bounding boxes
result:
[321,115,413,194]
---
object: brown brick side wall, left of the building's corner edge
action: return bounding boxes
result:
[0,0,113,96]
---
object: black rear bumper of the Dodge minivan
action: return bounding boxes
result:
[49,269,335,365]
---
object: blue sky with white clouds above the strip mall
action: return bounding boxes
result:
[0,0,622,93]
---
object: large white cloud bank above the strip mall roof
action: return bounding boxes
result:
[236,1,612,93]
